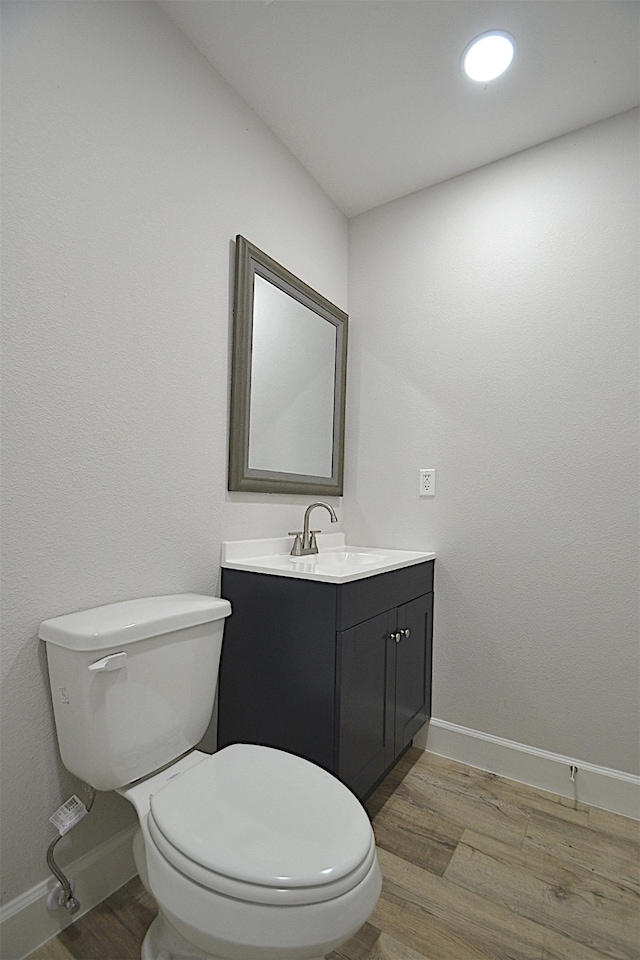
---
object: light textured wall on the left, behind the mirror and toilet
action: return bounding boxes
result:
[1,0,347,900]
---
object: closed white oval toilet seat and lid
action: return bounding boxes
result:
[147,744,375,905]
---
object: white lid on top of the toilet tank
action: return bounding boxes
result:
[38,593,231,650]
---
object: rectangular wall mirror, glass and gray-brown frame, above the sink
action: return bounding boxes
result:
[229,236,348,496]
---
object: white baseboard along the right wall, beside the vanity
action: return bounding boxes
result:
[413,718,640,820]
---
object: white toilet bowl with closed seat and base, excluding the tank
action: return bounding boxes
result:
[124,744,381,960]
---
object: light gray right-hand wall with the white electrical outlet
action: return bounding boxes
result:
[345,112,640,773]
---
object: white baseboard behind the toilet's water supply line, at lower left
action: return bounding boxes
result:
[0,824,137,960]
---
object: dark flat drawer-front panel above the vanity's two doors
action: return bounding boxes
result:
[336,560,434,631]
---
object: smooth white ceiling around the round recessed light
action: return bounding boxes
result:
[159,0,640,216]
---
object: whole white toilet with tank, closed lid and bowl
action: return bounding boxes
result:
[39,594,382,960]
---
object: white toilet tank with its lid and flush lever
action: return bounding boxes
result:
[39,593,231,790]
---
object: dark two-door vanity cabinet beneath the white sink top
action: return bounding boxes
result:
[218,560,434,799]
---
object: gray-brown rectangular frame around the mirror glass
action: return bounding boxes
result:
[228,235,349,496]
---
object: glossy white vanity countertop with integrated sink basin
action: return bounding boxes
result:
[222,533,435,583]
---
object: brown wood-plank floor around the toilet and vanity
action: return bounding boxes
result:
[22,748,640,960]
